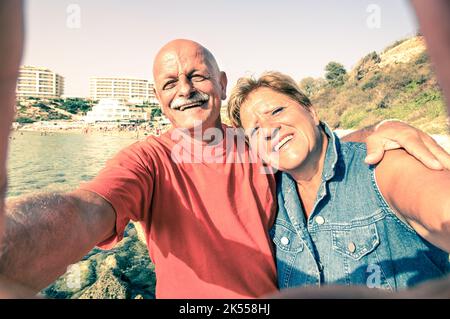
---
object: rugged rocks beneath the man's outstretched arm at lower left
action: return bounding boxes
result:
[42,223,156,299]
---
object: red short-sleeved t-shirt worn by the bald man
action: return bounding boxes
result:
[80,126,277,298]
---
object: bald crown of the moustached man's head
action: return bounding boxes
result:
[153,39,220,78]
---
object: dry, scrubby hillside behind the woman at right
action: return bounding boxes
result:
[300,36,449,134]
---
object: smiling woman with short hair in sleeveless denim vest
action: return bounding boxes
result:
[228,72,450,290]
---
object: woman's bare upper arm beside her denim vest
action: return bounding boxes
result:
[375,150,450,252]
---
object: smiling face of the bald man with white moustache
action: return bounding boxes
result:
[153,44,227,129]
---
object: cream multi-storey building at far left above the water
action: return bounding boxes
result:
[16,66,64,99]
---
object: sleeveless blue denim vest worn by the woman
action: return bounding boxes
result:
[270,123,450,290]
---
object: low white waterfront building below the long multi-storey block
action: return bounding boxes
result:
[84,99,148,123]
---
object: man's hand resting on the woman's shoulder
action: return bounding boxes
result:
[365,121,450,170]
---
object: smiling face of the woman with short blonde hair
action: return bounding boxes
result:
[240,88,320,171]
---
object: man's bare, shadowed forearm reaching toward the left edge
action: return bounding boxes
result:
[0,190,115,292]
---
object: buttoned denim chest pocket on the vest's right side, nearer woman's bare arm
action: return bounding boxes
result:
[332,224,380,260]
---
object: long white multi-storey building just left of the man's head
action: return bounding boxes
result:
[89,77,158,105]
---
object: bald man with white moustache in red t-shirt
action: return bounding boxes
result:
[0,40,448,298]
